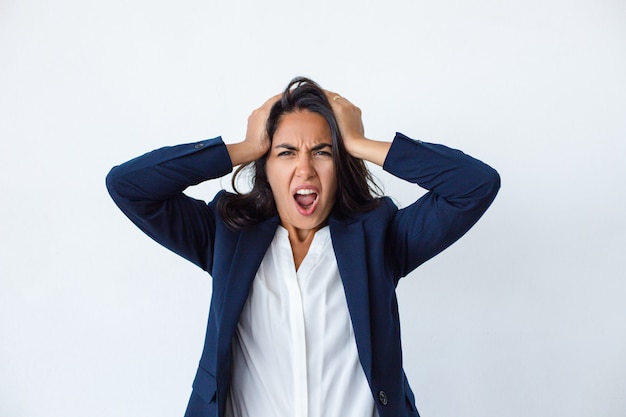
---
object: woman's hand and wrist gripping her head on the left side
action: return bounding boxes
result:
[226,94,281,166]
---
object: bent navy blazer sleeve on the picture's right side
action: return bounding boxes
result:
[383,133,500,280]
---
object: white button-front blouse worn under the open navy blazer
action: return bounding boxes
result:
[226,226,378,417]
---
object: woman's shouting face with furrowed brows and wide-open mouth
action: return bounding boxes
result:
[266,110,337,236]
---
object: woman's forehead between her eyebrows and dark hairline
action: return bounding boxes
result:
[274,110,331,143]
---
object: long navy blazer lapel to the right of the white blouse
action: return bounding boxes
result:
[329,217,372,380]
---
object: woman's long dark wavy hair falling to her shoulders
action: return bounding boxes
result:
[217,77,382,230]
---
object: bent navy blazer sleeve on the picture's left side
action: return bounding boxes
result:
[106,137,232,272]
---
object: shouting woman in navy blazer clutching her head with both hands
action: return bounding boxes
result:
[107,78,500,417]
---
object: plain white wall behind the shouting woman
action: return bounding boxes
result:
[0,0,626,417]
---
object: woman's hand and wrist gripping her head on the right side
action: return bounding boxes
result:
[324,90,391,166]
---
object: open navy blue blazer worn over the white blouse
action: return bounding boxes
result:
[107,133,500,417]
